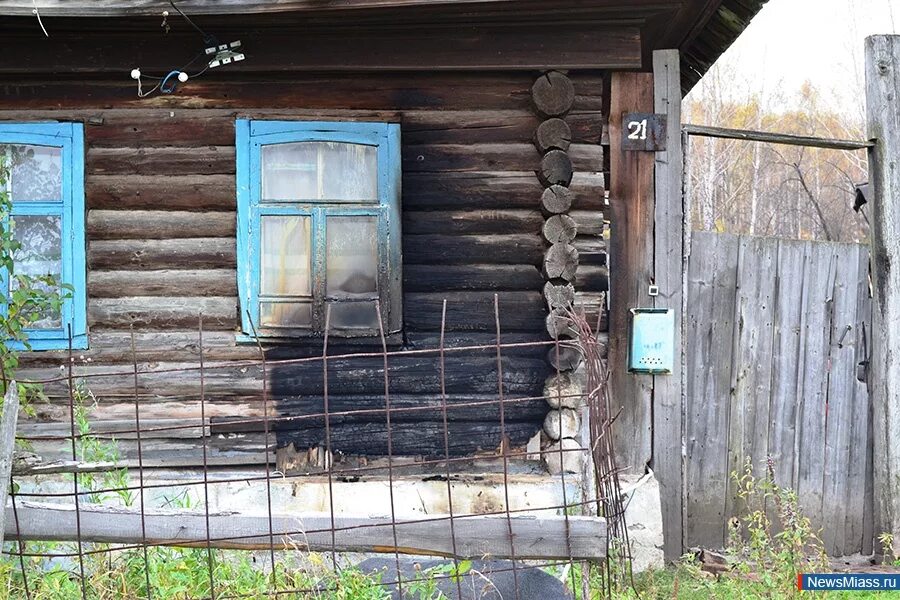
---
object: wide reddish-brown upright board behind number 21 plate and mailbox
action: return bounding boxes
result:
[609,73,654,474]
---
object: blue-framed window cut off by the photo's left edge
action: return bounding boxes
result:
[0,123,88,350]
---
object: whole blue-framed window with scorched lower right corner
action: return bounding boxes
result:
[235,119,402,338]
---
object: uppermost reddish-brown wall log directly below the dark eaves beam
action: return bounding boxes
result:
[0,73,605,111]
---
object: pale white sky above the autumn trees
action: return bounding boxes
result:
[689,0,900,110]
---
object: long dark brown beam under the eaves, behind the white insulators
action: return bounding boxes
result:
[0,23,641,73]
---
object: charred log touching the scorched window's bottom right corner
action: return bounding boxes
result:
[403,291,546,332]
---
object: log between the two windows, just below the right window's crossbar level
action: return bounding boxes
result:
[87,210,237,241]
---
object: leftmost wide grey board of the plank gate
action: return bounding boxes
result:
[685,232,738,548]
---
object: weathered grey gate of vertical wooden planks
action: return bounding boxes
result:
[684,232,874,555]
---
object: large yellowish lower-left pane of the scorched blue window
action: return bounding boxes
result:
[259,216,310,296]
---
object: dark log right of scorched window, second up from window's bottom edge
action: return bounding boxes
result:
[403,264,544,292]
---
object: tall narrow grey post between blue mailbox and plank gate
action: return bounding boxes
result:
[651,50,685,560]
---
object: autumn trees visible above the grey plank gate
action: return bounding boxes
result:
[684,79,868,242]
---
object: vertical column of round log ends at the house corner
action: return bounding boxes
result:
[531,71,584,474]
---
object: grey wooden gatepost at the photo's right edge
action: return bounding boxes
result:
[866,35,900,554]
